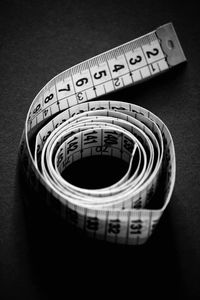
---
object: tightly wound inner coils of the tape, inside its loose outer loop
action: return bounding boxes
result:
[38,110,163,209]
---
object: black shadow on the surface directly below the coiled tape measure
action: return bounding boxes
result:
[17,156,180,299]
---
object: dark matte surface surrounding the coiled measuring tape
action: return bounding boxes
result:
[0,0,200,299]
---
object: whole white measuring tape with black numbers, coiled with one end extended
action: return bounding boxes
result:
[19,23,186,244]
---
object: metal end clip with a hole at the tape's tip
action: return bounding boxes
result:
[156,23,187,66]
